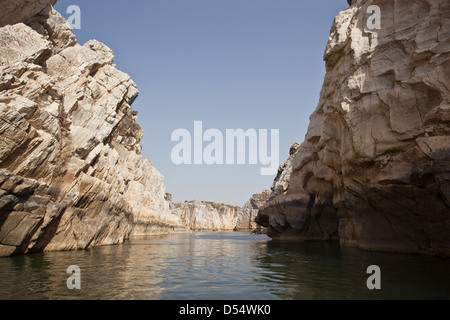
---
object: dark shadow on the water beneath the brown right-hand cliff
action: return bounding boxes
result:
[251,242,450,300]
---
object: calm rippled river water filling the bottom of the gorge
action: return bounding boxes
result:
[0,232,450,300]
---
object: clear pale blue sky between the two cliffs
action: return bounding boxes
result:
[55,0,348,206]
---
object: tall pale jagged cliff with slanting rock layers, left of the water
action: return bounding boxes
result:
[0,0,185,255]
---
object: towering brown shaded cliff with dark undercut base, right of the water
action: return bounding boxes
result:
[258,0,450,256]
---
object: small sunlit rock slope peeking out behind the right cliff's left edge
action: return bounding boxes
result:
[234,190,271,233]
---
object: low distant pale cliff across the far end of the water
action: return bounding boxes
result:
[171,200,242,231]
